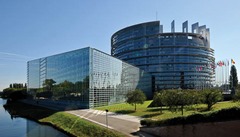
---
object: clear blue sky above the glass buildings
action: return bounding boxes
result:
[0,0,240,91]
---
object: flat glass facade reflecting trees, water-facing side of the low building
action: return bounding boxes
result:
[28,48,89,108]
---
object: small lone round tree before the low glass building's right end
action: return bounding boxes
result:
[126,89,146,111]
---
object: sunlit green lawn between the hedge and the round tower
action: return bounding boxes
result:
[95,100,240,120]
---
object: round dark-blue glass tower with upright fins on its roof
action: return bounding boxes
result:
[111,21,215,91]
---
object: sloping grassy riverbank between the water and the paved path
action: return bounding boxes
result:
[4,102,124,137]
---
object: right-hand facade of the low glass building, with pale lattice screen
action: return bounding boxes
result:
[90,49,152,107]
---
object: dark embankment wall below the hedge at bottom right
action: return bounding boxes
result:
[141,120,240,137]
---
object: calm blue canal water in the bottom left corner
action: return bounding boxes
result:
[0,98,68,137]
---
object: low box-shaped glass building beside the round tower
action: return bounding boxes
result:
[28,47,152,108]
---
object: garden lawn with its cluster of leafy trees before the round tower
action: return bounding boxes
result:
[95,89,240,125]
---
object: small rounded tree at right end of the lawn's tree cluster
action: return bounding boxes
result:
[202,88,223,110]
